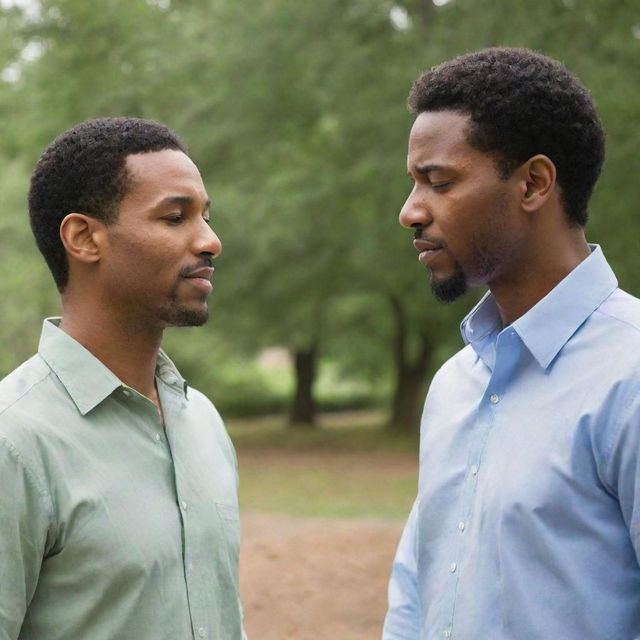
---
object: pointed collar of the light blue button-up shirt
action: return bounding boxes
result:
[461,245,618,369]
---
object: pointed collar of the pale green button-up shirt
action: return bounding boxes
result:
[38,318,187,415]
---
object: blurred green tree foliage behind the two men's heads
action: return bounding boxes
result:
[0,0,640,430]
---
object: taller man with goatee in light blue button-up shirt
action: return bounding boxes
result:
[383,48,640,640]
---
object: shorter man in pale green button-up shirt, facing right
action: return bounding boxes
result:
[0,118,243,640]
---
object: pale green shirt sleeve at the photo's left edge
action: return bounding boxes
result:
[0,436,51,640]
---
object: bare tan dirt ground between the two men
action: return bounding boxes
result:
[240,512,402,640]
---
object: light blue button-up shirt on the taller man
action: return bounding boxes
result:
[383,247,640,640]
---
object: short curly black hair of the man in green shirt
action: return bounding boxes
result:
[29,118,187,291]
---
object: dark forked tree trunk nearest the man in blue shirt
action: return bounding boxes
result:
[389,296,433,431]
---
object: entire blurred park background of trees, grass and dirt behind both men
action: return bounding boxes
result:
[0,0,640,640]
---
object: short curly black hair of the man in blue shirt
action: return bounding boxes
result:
[407,47,605,226]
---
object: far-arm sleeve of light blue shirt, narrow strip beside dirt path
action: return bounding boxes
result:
[382,499,420,640]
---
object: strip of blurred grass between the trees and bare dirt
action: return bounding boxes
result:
[228,412,417,520]
